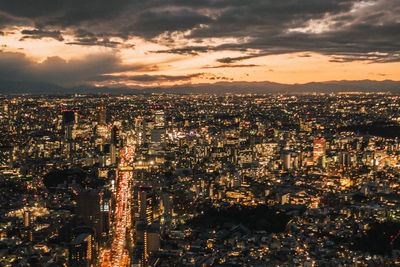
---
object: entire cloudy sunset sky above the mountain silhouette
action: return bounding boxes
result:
[0,0,400,86]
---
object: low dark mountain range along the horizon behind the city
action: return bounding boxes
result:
[0,80,400,94]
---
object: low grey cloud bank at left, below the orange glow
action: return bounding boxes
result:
[0,52,153,86]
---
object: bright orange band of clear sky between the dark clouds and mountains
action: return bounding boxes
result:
[0,30,400,86]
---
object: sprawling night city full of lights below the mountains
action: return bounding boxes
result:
[0,92,400,267]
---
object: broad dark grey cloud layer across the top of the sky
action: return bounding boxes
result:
[0,0,400,64]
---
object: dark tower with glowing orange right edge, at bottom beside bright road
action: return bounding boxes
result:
[69,233,93,267]
